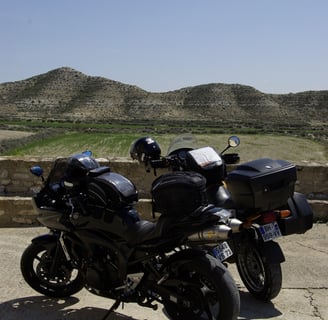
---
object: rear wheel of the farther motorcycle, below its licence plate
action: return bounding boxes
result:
[236,243,282,301]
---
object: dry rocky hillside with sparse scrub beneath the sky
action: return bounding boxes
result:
[0,68,328,126]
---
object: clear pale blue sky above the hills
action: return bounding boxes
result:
[0,0,328,93]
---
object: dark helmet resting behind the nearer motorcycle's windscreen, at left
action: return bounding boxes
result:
[65,151,99,183]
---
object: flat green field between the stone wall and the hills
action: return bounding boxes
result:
[4,132,328,163]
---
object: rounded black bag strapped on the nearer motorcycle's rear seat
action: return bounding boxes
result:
[151,171,207,216]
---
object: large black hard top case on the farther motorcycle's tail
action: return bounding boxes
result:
[226,158,297,211]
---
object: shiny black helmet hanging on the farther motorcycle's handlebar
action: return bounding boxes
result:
[130,137,161,164]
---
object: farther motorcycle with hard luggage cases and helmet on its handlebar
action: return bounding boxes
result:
[130,135,313,301]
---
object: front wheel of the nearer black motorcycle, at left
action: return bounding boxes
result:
[20,243,84,298]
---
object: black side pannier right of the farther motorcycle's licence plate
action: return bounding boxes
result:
[278,192,313,236]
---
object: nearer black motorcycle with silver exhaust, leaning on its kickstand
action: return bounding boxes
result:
[21,151,240,320]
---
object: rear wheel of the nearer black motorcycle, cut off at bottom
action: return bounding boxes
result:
[163,255,240,320]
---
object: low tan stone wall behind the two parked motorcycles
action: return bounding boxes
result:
[0,157,328,227]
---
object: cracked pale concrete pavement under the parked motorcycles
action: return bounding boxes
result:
[0,224,328,320]
